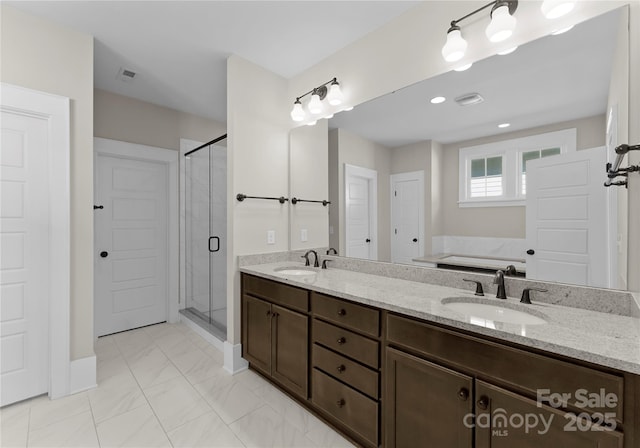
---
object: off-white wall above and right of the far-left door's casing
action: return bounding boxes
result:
[0,5,93,360]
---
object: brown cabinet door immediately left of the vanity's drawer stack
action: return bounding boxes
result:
[271,305,309,398]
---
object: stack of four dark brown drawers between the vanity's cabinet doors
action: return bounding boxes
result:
[311,292,380,447]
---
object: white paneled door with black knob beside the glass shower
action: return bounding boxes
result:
[95,154,169,336]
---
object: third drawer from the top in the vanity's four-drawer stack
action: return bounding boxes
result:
[312,344,379,399]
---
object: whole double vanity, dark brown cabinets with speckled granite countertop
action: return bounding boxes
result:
[240,262,640,448]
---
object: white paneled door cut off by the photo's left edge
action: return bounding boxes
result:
[0,110,50,406]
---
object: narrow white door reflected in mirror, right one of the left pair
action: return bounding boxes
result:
[391,171,425,264]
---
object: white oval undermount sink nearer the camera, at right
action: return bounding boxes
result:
[442,298,547,325]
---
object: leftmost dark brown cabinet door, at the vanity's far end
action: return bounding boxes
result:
[242,294,272,375]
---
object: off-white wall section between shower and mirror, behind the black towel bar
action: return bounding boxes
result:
[227,56,290,344]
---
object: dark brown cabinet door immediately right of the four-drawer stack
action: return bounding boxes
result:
[384,348,476,448]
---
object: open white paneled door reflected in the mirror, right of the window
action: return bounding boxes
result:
[526,148,610,287]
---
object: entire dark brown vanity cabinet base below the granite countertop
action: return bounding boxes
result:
[242,274,640,448]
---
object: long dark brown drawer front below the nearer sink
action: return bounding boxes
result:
[387,314,624,421]
